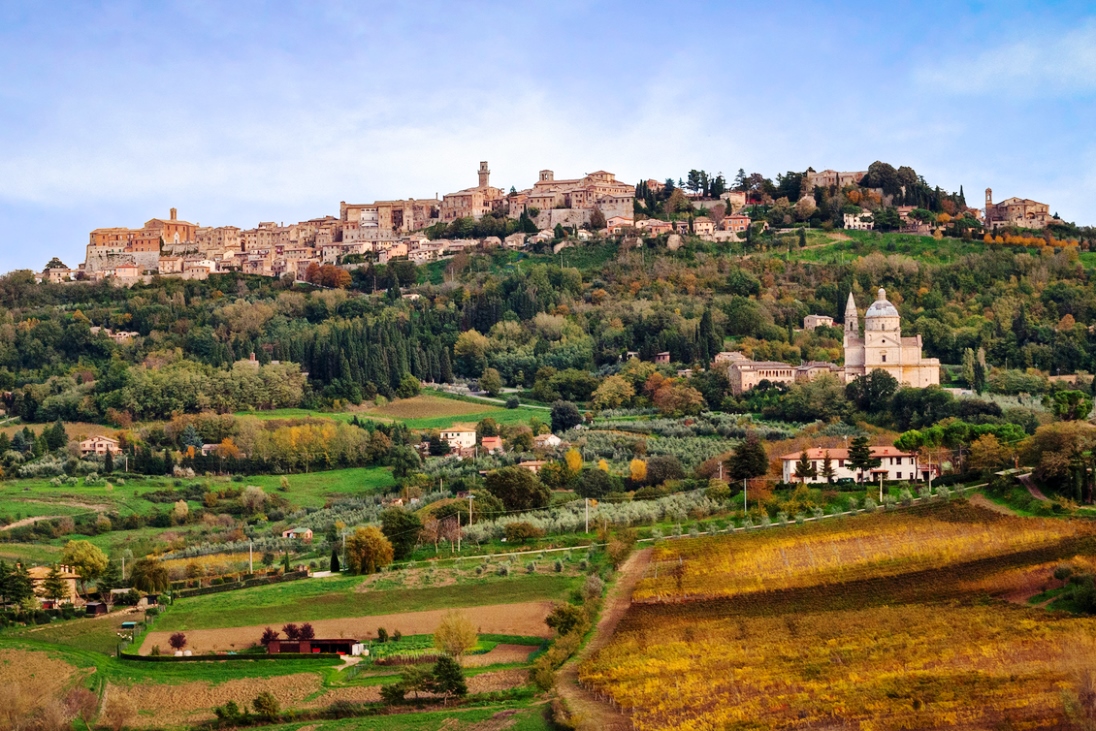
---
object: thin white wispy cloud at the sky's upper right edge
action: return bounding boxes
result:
[914,22,1096,100]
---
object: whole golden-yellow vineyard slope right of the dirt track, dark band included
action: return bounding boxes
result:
[580,504,1096,731]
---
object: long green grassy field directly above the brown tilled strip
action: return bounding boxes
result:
[156,574,580,631]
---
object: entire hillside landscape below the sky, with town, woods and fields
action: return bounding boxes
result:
[6,162,1096,731]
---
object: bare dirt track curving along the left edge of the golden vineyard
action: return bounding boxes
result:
[556,548,652,731]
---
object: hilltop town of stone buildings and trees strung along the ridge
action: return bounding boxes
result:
[41,161,1074,284]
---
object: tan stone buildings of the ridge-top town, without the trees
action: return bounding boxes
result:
[41,161,1052,284]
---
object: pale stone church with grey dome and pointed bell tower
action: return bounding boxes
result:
[845,288,940,388]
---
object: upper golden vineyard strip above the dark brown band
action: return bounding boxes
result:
[633,504,1096,602]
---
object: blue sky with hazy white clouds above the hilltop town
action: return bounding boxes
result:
[0,0,1096,271]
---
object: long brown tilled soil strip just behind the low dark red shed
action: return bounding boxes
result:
[140,602,552,654]
